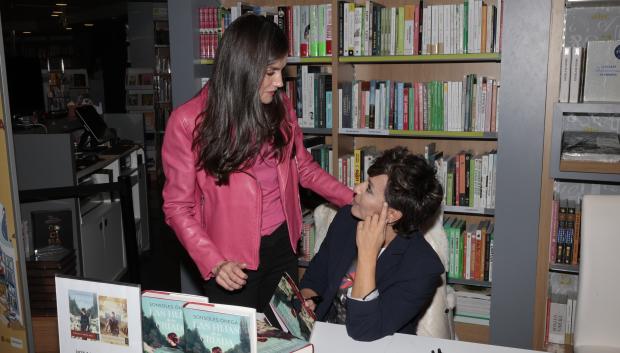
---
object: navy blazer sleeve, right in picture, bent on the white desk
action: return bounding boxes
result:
[346,256,441,341]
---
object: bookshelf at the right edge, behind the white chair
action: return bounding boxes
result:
[534,0,620,351]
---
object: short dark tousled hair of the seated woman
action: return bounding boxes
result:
[368,146,443,235]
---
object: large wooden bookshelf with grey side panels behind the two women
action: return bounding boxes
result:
[168,0,551,347]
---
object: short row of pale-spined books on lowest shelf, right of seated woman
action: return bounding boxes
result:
[454,288,491,326]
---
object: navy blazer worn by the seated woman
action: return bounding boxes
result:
[300,205,445,341]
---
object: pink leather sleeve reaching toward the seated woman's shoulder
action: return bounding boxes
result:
[283,95,353,207]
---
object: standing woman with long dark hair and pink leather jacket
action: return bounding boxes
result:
[162,14,353,311]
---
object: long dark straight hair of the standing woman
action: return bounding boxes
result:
[192,14,290,185]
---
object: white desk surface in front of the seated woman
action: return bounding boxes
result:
[310,321,538,353]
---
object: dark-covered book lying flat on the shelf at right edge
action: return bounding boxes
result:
[561,131,620,163]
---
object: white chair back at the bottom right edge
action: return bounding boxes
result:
[574,195,620,353]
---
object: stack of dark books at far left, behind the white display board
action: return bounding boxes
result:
[26,248,76,316]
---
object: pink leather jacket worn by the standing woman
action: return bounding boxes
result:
[162,89,353,280]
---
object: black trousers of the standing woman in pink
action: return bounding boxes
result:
[204,222,299,316]
